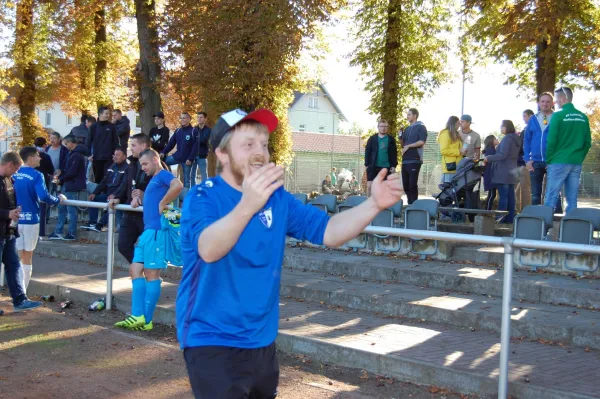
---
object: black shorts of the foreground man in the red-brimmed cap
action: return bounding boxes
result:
[183,343,279,399]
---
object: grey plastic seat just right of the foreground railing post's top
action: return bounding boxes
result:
[513,205,554,271]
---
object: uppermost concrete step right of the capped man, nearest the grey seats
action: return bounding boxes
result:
[284,247,600,309]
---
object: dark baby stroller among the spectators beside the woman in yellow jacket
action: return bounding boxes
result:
[434,158,485,221]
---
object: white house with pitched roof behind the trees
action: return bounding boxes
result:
[288,84,348,134]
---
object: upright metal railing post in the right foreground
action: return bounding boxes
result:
[498,238,514,399]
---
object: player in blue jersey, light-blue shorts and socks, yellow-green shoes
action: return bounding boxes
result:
[115,149,183,331]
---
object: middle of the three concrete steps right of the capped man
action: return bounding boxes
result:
[281,270,600,350]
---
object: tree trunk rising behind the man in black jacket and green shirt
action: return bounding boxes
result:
[381,0,401,134]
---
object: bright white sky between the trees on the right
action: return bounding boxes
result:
[323,14,595,135]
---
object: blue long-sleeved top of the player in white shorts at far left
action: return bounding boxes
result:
[13,166,60,224]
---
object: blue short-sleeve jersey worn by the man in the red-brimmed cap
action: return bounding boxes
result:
[176,177,329,348]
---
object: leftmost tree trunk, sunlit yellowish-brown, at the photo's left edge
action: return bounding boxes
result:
[14,0,42,145]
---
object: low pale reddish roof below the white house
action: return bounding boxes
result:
[292,132,365,154]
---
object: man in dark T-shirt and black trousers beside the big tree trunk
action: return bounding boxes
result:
[400,108,427,205]
